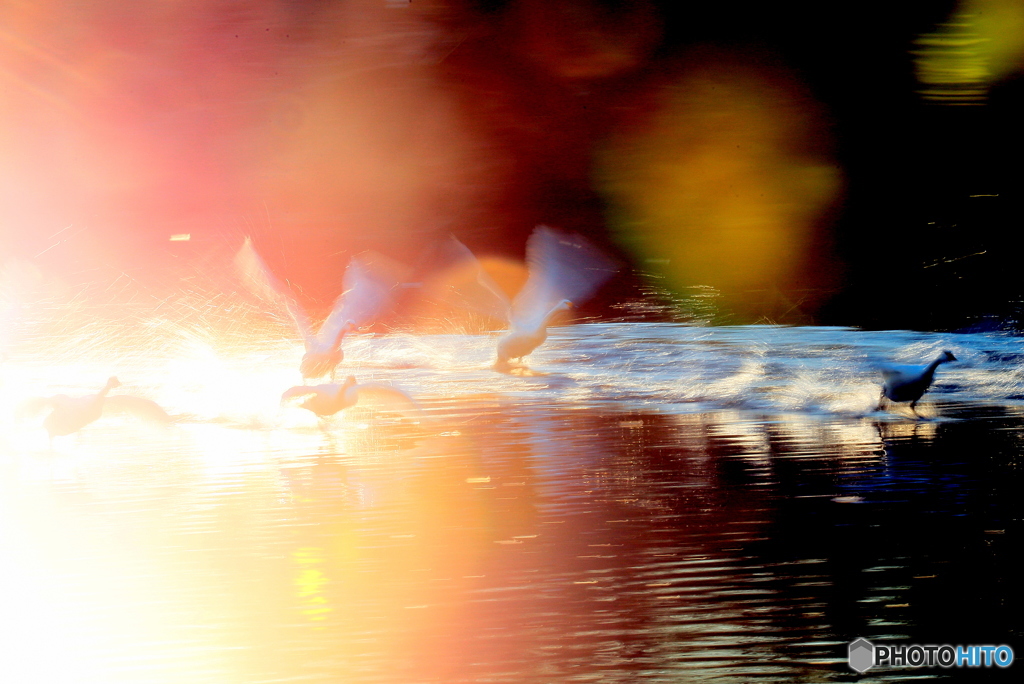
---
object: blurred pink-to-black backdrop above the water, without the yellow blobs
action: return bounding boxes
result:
[0,0,1024,330]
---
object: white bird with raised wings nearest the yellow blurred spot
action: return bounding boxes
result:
[450,225,618,373]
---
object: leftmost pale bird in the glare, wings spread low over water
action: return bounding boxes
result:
[22,377,171,440]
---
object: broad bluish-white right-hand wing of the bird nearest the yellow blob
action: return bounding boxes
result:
[512,225,618,329]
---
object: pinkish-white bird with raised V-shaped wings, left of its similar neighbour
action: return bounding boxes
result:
[234,238,397,380]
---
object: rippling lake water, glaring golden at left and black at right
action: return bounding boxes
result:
[0,324,1024,684]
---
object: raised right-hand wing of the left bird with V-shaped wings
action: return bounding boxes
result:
[317,252,406,348]
